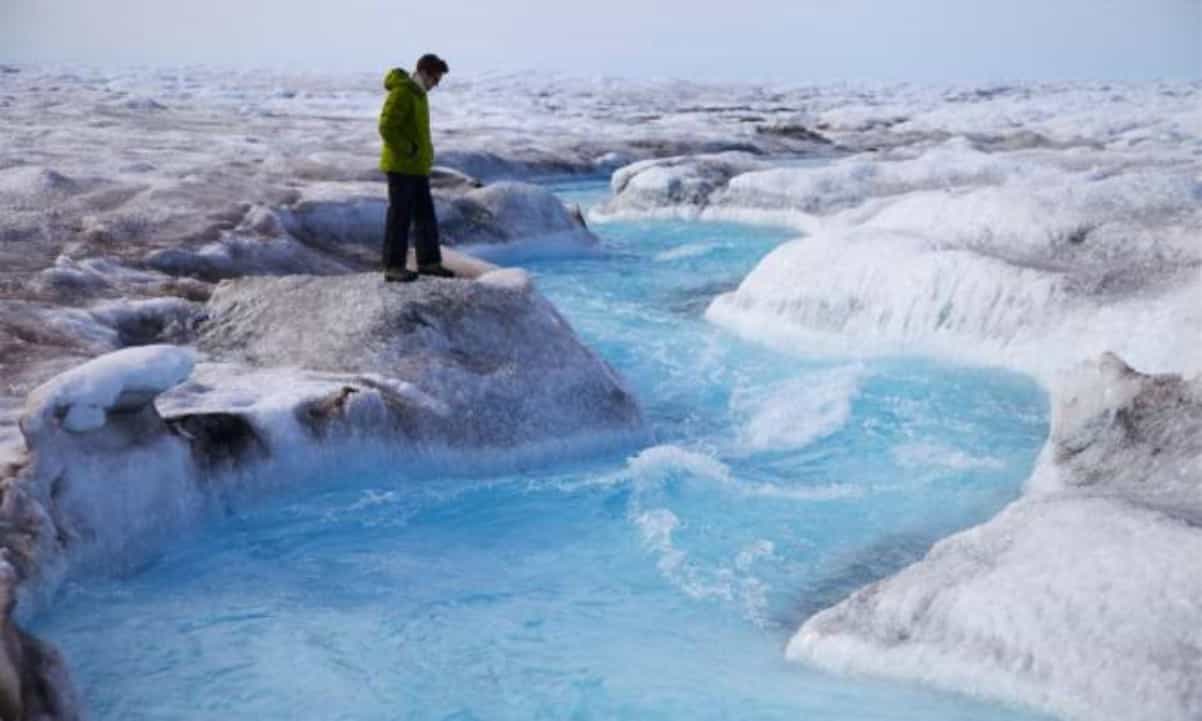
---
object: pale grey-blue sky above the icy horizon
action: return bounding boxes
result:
[7,0,1202,82]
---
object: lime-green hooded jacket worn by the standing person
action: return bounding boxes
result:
[380,67,434,175]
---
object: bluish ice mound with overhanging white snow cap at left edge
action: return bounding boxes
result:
[0,345,196,586]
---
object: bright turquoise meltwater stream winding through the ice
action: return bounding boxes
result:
[34,184,1047,721]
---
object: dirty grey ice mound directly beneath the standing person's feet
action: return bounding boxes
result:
[189,270,641,451]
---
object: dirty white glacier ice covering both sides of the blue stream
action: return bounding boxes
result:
[0,67,1202,721]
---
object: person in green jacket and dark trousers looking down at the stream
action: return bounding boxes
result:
[380,54,454,282]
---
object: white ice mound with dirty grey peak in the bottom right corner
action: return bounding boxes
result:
[787,356,1202,721]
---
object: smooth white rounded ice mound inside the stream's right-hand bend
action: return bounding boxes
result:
[707,223,1202,381]
